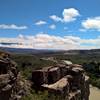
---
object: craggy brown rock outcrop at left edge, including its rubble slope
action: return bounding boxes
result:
[0,52,27,100]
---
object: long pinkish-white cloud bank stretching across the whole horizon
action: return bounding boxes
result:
[0,33,100,50]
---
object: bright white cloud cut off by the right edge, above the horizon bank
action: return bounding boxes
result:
[81,16,100,31]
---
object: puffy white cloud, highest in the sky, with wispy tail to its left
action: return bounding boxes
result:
[50,8,80,23]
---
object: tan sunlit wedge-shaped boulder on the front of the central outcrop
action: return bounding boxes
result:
[42,78,69,97]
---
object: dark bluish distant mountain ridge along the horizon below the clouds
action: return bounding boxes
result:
[0,47,100,55]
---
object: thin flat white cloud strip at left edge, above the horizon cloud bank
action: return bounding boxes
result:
[0,24,28,30]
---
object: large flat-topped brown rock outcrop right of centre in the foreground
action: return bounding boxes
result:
[32,63,90,100]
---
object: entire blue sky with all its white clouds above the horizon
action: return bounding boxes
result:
[0,0,100,50]
